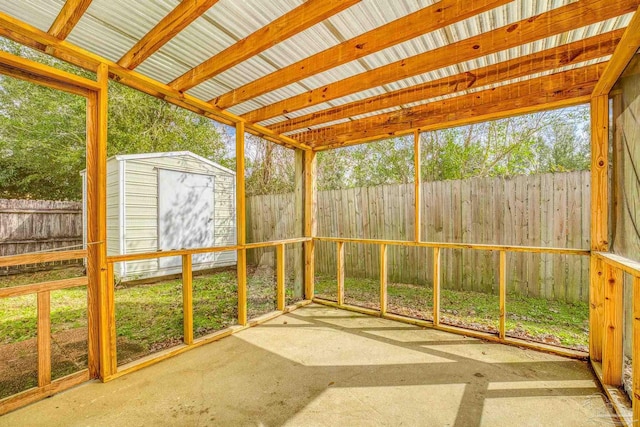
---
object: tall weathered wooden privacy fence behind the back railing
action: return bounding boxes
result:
[247,171,590,302]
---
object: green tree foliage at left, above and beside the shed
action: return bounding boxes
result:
[0,40,234,200]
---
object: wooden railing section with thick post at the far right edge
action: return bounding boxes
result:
[591,252,640,426]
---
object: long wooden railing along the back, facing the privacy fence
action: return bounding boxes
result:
[314,237,590,358]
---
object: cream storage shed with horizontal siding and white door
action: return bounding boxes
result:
[83,151,237,281]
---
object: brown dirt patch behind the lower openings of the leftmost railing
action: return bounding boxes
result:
[0,328,87,399]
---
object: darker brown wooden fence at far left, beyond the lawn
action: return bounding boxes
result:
[0,199,82,274]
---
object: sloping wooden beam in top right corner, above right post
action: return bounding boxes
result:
[593,8,640,97]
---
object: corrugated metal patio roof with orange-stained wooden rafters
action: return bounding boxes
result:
[0,0,640,149]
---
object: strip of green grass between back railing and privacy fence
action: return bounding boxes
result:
[315,276,589,350]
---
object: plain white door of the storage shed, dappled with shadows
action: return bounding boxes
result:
[158,169,215,268]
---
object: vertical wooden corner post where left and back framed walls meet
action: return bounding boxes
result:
[304,151,316,300]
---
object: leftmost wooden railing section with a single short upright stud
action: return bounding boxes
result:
[0,250,89,415]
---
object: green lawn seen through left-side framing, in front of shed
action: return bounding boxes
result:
[0,266,296,398]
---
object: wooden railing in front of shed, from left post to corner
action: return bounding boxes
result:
[100,237,311,381]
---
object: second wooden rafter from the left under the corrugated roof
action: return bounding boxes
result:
[118,0,218,70]
